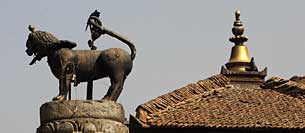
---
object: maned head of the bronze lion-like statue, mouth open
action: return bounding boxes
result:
[25,25,59,65]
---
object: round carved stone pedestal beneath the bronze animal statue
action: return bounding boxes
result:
[36,100,129,133]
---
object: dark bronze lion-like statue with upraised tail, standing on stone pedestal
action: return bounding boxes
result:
[26,26,136,101]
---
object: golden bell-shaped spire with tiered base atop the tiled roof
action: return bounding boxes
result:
[220,10,267,85]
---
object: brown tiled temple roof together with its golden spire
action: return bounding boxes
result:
[130,11,305,130]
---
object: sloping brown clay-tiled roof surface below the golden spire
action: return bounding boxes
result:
[131,75,305,129]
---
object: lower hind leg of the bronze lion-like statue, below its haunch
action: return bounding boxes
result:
[103,74,124,101]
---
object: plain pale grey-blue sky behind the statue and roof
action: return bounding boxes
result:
[0,0,305,133]
